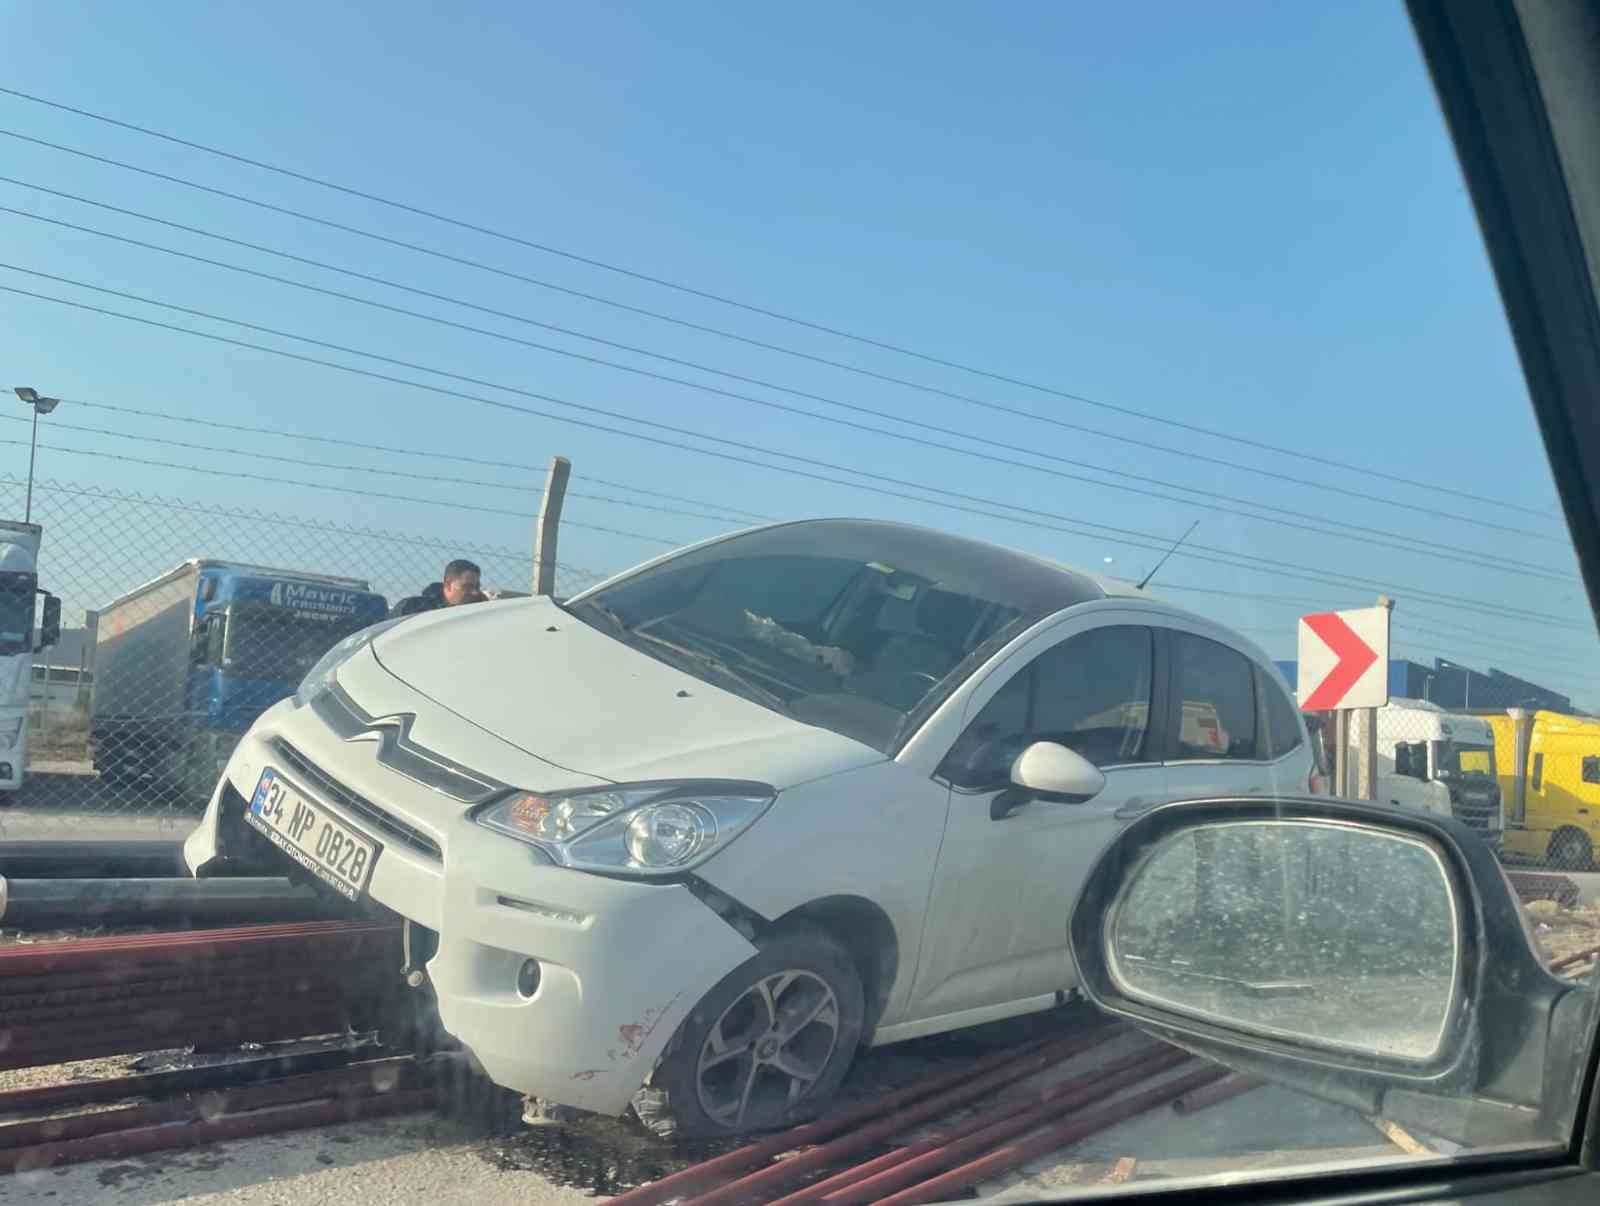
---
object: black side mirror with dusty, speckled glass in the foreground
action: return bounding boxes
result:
[1070,798,1600,1145]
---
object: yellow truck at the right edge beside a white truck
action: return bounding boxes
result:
[1486,709,1600,870]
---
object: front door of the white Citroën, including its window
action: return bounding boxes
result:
[910,613,1166,1020]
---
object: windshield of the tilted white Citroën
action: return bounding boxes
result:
[570,520,1104,752]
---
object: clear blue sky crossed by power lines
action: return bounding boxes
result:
[0,2,1600,702]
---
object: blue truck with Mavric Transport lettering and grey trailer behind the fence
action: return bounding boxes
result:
[90,560,389,801]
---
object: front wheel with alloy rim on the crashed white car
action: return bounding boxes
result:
[634,924,866,1139]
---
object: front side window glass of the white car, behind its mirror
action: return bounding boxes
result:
[939,625,1154,790]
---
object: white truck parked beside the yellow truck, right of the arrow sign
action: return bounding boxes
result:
[1350,699,1506,849]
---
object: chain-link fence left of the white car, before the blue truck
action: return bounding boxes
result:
[0,477,605,817]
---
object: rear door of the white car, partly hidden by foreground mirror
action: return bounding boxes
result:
[1162,627,1312,798]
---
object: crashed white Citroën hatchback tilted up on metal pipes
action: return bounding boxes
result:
[186,520,1315,1134]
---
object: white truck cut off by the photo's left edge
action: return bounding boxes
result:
[0,520,61,792]
